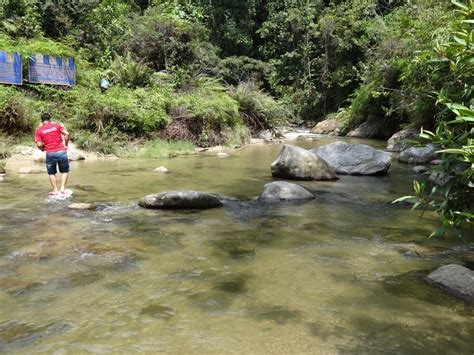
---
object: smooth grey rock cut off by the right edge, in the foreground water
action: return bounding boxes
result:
[426,264,474,303]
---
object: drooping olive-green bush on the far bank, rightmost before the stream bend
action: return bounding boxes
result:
[231,82,291,134]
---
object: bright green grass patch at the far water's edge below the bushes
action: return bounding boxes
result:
[124,140,195,159]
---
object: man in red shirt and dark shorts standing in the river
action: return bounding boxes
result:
[35,113,69,195]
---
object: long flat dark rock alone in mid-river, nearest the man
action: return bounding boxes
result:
[138,190,222,209]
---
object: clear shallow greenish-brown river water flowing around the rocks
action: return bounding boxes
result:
[0,139,474,353]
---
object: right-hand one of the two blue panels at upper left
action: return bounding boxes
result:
[28,54,76,86]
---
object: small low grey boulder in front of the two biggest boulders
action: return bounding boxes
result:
[258,181,314,203]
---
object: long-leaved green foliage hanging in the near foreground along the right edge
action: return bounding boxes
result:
[399,1,474,238]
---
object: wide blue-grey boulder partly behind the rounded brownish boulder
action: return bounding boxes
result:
[311,142,392,175]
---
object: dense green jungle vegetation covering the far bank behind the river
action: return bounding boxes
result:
[0,0,462,152]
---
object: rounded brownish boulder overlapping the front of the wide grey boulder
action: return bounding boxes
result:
[271,144,338,180]
